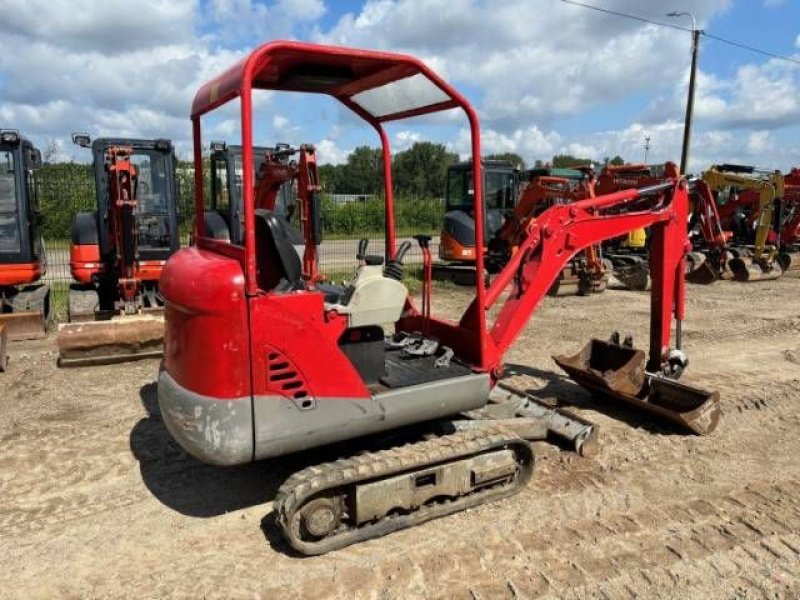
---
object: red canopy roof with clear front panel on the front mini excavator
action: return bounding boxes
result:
[192,41,466,123]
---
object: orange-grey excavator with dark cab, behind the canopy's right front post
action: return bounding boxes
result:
[433,159,520,285]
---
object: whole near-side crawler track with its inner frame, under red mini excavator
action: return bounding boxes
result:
[274,427,534,555]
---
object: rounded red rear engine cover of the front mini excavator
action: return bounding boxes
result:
[160,248,250,398]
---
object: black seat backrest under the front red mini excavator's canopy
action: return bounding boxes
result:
[255,208,303,290]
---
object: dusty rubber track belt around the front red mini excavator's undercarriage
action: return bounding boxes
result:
[274,427,534,555]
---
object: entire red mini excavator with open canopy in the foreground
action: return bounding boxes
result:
[158,42,719,554]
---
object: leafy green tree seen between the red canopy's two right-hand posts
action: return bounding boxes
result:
[392,142,458,198]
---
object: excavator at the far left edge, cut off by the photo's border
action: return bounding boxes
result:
[0,129,51,370]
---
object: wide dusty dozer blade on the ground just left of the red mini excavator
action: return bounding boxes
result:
[58,315,164,367]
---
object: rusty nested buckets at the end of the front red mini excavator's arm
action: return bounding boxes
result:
[553,339,720,435]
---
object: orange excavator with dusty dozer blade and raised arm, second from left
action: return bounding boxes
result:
[58,134,180,366]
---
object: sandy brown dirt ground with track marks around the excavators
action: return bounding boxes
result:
[0,279,800,599]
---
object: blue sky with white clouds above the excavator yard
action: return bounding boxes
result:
[0,0,800,170]
